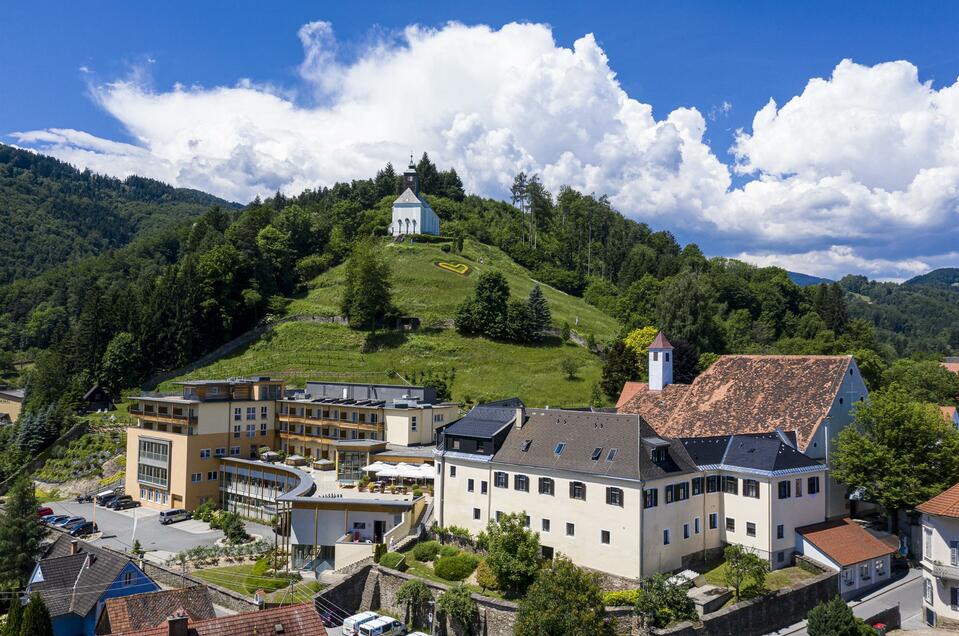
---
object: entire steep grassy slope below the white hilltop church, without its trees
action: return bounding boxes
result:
[166,241,619,406]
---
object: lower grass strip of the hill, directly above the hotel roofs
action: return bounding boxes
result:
[168,322,602,406]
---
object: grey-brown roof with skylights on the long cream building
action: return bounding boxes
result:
[493,409,696,480]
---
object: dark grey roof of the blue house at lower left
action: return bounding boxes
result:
[29,534,139,616]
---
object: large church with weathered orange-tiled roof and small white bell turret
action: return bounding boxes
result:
[618,334,869,517]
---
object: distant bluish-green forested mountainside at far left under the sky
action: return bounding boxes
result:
[0,144,236,284]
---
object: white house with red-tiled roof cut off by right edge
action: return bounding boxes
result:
[916,484,959,630]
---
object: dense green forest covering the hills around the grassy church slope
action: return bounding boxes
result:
[0,149,959,480]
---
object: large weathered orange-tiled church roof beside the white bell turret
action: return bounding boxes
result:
[618,355,852,450]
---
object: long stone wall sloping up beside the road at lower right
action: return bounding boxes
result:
[651,572,839,636]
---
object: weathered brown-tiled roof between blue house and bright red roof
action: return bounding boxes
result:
[96,585,216,634]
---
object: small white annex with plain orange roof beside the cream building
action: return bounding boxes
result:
[796,518,896,599]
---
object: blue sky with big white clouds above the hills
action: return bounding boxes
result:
[0,2,959,279]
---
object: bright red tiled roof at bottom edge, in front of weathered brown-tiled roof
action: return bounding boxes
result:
[108,603,326,636]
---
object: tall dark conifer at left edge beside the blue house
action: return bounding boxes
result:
[0,477,44,589]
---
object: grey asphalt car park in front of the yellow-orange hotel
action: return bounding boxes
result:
[47,501,273,556]
